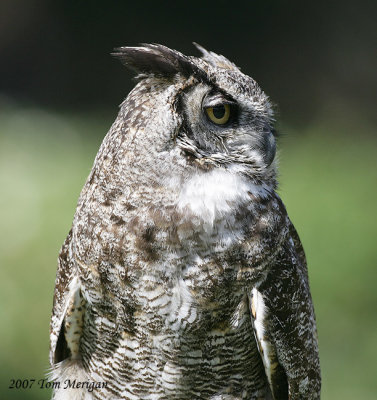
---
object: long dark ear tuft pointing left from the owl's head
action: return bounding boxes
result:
[112,44,205,79]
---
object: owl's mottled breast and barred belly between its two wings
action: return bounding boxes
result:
[72,176,283,399]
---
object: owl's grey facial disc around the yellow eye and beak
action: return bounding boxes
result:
[178,85,276,170]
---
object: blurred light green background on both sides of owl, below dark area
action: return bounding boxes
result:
[0,107,377,400]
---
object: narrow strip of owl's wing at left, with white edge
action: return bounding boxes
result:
[50,231,85,367]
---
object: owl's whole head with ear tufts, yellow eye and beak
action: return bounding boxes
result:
[114,44,276,186]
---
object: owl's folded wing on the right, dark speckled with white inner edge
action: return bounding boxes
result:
[249,218,321,400]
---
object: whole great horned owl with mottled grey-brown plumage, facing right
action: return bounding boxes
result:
[50,44,320,400]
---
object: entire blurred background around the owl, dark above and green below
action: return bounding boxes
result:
[0,0,377,400]
